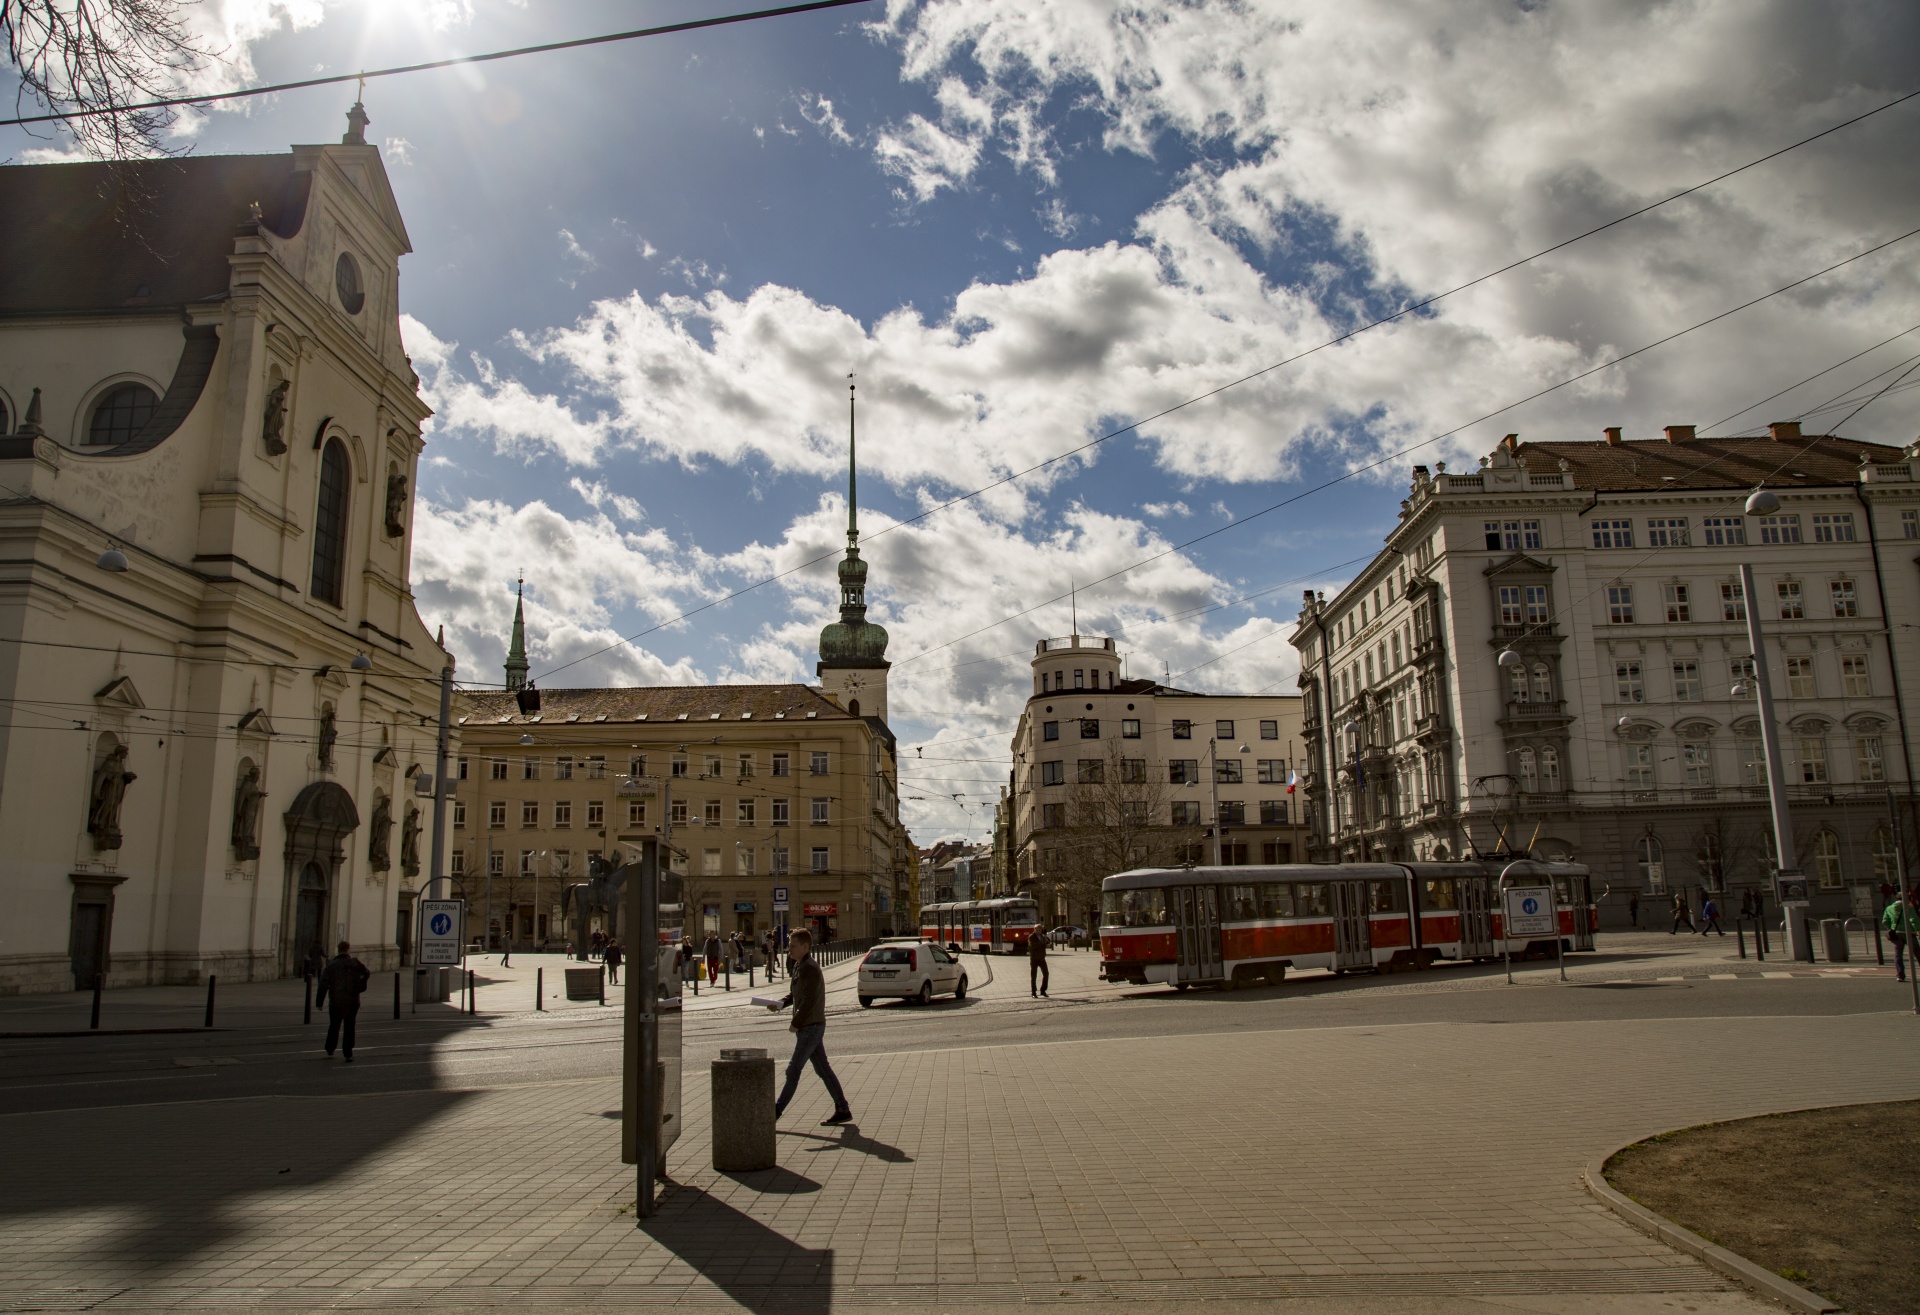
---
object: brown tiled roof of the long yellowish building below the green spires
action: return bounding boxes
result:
[455,685,864,731]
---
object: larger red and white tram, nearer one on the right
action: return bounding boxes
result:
[1100,862,1599,989]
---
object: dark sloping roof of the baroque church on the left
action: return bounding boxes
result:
[0,152,313,315]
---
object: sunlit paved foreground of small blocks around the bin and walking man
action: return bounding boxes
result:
[0,956,1920,1311]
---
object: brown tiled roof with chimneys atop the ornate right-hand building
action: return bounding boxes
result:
[1515,434,1905,491]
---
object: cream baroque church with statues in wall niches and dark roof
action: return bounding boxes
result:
[0,106,451,992]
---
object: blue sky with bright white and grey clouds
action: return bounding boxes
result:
[0,0,1920,845]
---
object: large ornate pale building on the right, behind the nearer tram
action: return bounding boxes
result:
[1294,424,1920,910]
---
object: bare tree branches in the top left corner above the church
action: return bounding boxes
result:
[0,0,215,159]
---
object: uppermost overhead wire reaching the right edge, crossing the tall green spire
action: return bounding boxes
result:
[536,90,1920,680]
